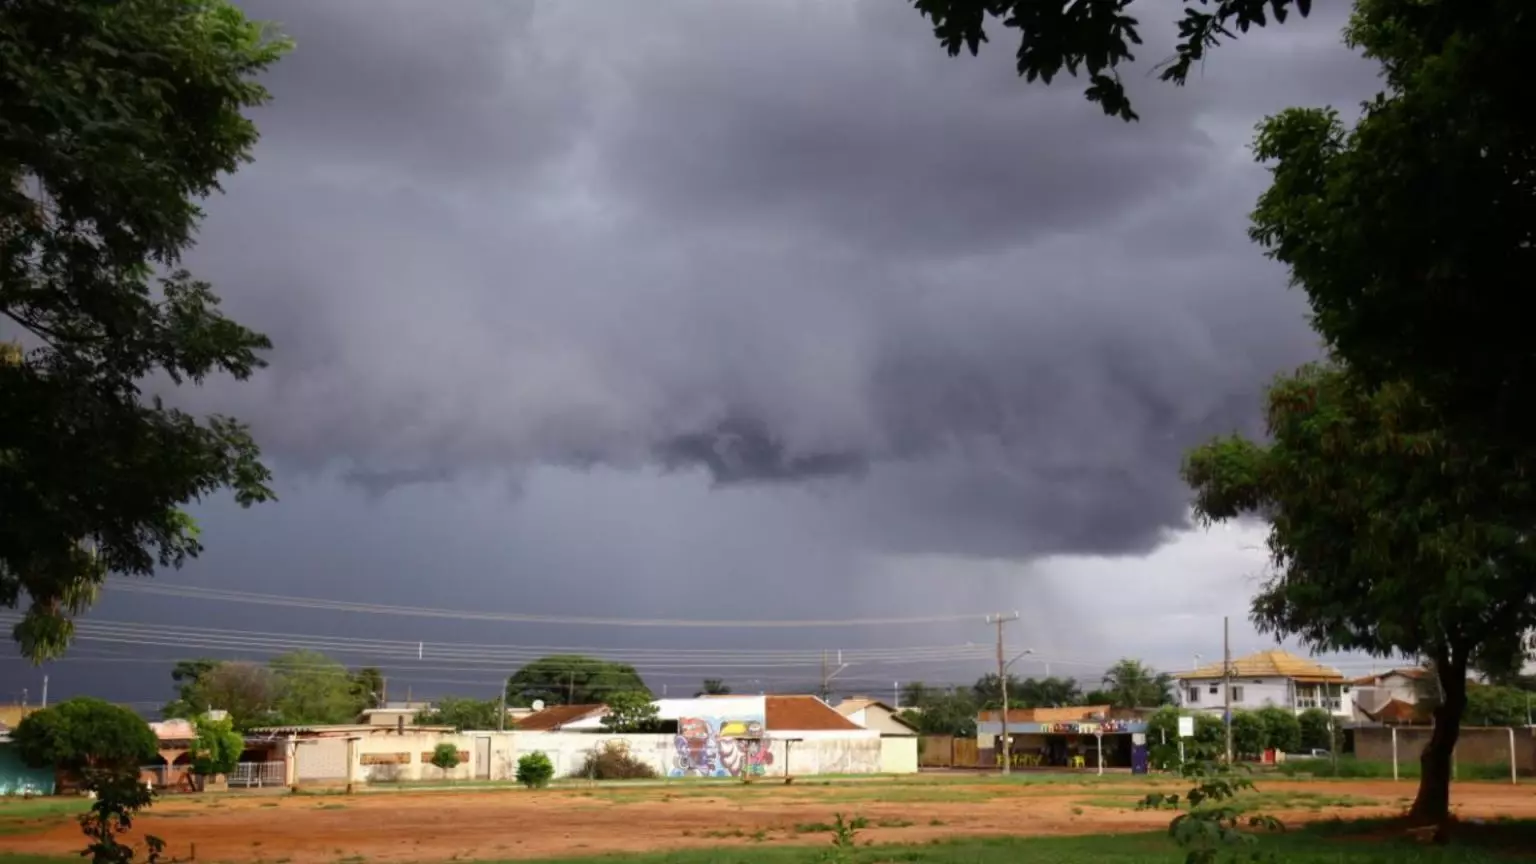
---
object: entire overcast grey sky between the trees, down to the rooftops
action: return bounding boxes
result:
[0,0,1400,701]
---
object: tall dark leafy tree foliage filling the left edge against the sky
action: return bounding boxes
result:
[0,0,287,661]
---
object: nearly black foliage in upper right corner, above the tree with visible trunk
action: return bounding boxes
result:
[1252,0,1536,470]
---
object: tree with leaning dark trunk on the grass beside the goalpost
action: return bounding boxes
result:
[1184,364,1536,822]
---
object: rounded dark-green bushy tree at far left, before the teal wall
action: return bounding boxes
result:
[11,696,158,776]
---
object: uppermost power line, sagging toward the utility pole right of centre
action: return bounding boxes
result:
[114,581,982,630]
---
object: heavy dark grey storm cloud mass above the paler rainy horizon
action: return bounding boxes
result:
[174,2,1388,555]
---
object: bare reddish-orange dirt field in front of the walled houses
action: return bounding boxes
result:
[9,778,1536,864]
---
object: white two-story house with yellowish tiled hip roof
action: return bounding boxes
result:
[1174,650,1355,718]
